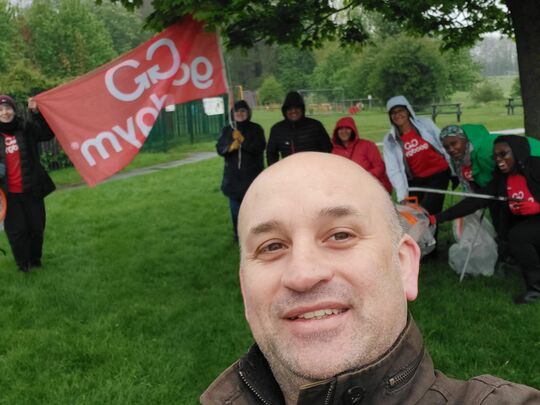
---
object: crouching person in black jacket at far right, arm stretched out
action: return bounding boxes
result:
[431,135,540,304]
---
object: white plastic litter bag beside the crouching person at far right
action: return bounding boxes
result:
[448,211,497,276]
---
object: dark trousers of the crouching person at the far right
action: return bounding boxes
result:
[508,214,540,291]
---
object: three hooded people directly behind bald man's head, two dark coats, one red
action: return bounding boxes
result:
[216,91,392,239]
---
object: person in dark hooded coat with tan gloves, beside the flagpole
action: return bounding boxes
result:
[216,100,266,240]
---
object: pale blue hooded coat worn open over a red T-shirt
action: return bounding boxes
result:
[383,96,451,201]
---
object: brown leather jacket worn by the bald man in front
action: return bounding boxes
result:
[200,317,540,405]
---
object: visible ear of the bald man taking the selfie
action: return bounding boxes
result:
[398,234,420,301]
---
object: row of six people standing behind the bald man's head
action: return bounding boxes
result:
[217,92,540,304]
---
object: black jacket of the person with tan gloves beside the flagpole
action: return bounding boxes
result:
[216,121,266,200]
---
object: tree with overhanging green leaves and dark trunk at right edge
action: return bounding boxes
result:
[116,0,540,139]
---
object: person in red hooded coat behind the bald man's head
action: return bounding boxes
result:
[332,117,392,193]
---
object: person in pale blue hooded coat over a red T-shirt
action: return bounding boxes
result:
[383,96,452,214]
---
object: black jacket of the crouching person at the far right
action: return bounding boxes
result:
[436,135,540,240]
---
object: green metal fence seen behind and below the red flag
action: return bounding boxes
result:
[39,96,228,170]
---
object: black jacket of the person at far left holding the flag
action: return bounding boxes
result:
[0,114,55,197]
